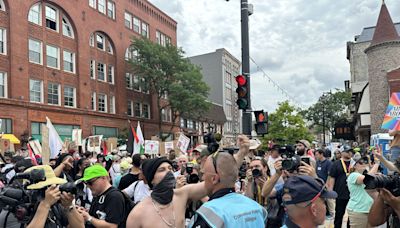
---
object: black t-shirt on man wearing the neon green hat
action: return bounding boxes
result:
[86,187,125,228]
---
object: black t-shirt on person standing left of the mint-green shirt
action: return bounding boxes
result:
[329,160,350,199]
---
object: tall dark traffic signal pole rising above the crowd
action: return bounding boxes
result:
[240,0,252,135]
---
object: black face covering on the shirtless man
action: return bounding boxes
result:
[151,172,176,205]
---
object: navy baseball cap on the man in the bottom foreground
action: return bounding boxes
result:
[283,175,337,205]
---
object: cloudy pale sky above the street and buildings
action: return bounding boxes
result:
[150,0,400,112]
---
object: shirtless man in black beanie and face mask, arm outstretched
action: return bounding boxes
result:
[126,136,249,228]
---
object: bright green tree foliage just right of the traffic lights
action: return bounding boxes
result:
[265,101,313,144]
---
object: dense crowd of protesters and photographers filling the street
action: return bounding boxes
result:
[0,135,400,228]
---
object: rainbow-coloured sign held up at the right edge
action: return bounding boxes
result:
[381,93,400,131]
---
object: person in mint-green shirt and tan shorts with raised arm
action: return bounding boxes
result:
[347,154,379,228]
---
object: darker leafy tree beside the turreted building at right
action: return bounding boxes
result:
[301,89,351,135]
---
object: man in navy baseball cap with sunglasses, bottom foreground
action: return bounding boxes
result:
[283,176,337,228]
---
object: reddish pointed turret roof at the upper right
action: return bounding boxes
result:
[371,1,400,46]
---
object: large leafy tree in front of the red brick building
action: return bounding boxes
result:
[130,38,210,140]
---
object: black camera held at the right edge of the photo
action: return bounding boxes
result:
[364,173,400,197]
